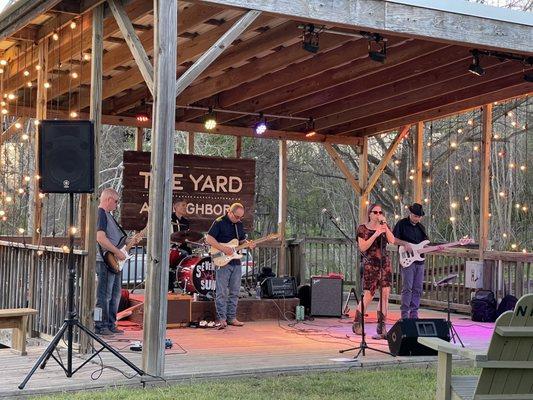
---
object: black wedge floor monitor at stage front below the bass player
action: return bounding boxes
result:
[387,318,450,356]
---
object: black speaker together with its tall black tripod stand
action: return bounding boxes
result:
[18,120,144,389]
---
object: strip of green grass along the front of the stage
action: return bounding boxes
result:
[37,368,479,400]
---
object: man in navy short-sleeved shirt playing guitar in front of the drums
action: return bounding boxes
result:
[205,203,255,329]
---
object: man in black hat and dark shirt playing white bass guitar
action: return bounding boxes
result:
[392,203,440,319]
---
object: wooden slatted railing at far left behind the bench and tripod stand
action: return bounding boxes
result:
[0,241,87,341]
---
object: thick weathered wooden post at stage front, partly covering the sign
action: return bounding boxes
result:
[142,0,178,376]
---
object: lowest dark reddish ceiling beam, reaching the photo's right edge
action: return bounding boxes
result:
[350,84,533,136]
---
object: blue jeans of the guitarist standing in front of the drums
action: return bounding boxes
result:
[215,261,242,321]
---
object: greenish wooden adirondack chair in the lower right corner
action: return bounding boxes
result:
[418,294,533,400]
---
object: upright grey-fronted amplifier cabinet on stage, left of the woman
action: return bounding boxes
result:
[310,276,342,317]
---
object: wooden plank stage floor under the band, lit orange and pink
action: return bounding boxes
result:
[0,302,493,398]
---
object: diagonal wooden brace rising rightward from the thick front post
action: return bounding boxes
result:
[176,10,261,97]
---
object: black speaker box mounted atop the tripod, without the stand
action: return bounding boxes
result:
[39,120,94,193]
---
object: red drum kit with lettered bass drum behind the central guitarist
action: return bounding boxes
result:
[170,231,216,298]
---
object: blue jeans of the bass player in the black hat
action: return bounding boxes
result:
[400,261,424,319]
